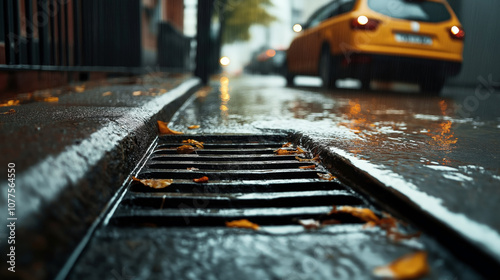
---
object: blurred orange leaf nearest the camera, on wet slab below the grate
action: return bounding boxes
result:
[373,251,429,279]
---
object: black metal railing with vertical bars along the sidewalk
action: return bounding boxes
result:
[0,0,191,72]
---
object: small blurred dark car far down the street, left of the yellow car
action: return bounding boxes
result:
[246,48,286,75]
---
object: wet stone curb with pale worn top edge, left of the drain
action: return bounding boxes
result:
[0,78,201,279]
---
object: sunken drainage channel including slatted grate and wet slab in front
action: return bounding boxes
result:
[67,134,477,279]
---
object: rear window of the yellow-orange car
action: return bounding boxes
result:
[368,0,451,22]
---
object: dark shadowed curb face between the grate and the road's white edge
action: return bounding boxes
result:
[292,133,500,279]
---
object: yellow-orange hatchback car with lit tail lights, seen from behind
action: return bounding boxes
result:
[286,0,465,92]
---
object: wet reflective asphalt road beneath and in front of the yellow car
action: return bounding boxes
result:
[171,75,500,259]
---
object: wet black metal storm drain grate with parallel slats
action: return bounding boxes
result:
[110,134,376,227]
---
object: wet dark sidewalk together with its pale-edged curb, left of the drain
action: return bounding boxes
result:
[0,74,200,279]
